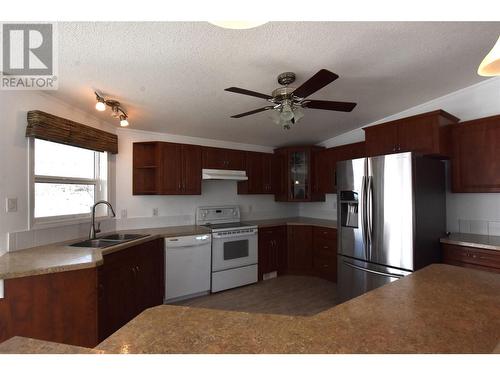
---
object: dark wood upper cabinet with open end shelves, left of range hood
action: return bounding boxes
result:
[133,142,201,195]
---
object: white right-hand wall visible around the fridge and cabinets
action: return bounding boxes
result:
[306,77,500,235]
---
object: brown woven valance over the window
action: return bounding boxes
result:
[26,111,118,154]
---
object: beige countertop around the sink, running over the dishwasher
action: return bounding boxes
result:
[0,225,209,279]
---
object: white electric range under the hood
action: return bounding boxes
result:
[196,206,258,292]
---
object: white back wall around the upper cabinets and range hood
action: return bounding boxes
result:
[116,129,298,229]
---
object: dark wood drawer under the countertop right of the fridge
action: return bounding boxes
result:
[443,244,500,269]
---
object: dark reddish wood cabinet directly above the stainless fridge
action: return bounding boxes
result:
[363,110,459,157]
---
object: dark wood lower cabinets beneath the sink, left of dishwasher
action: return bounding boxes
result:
[0,239,165,347]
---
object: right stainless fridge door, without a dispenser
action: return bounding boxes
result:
[366,152,414,271]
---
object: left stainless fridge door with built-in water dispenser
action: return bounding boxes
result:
[337,158,367,259]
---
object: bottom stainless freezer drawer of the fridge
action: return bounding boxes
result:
[337,255,411,303]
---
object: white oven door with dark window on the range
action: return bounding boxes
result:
[212,230,257,272]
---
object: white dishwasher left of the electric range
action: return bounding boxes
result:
[165,234,212,302]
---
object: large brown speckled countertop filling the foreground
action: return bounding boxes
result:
[96,264,500,353]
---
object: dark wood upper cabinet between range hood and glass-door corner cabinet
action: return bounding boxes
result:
[238,151,281,194]
